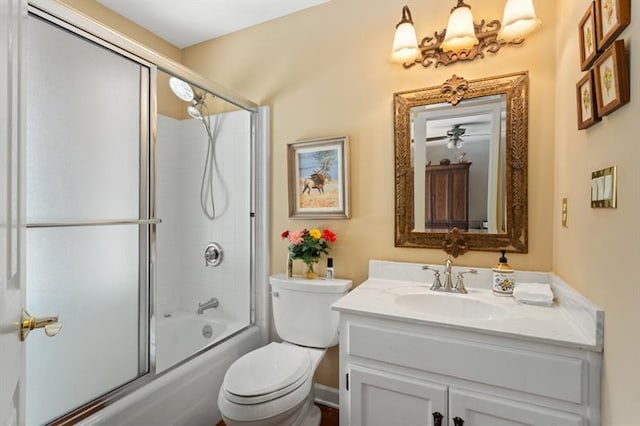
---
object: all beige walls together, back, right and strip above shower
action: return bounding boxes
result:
[46,0,640,425]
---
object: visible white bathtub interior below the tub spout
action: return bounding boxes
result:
[151,312,243,373]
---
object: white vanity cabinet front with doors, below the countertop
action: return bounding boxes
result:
[340,311,601,426]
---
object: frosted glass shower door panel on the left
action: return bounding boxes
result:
[25,15,152,425]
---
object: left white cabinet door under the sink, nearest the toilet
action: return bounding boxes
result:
[348,366,447,426]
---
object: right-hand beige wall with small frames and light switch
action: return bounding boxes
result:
[553,0,640,425]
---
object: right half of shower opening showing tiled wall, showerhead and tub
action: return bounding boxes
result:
[154,71,253,373]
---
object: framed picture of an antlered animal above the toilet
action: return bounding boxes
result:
[287,136,349,219]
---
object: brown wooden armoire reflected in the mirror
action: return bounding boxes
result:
[425,163,471,230]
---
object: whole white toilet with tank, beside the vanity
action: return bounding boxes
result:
[218,274,351,426]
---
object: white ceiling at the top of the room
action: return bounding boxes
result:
[97,0,329,48]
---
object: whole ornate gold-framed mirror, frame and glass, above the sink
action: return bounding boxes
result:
[394,72,529,256]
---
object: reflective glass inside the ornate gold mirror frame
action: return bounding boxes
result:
[411,95,506,234]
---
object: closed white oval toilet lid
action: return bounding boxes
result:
[223,342,311,397]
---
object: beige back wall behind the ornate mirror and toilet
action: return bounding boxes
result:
[182,0,555,387]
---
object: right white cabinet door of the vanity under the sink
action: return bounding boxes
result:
[449,388,587,426]
